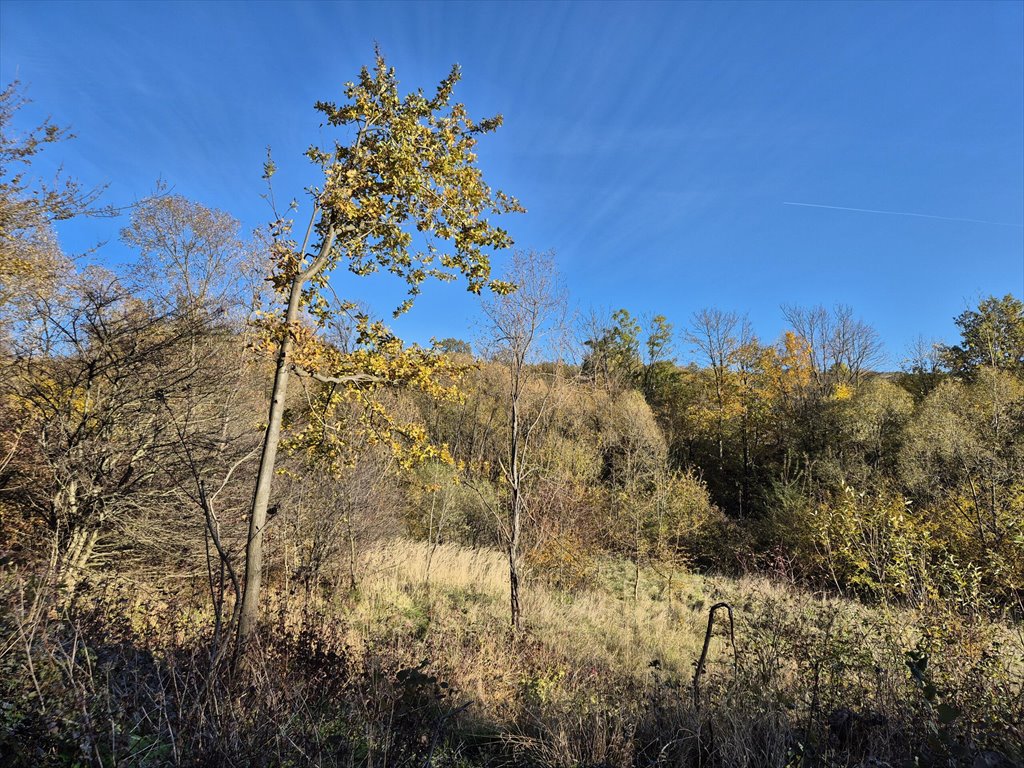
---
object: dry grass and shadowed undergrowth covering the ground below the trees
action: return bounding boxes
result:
[0,540,1024,766]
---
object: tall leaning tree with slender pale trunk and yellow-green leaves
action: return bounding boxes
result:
[238,51,522,647]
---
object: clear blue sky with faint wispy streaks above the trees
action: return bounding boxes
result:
[0,0,1024,362]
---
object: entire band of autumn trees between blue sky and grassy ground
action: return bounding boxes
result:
[0,55,1024,653]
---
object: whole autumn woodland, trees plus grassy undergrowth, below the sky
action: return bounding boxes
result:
[0,54,1024,768]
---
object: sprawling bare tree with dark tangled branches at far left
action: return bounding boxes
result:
[6,269,198,586]
